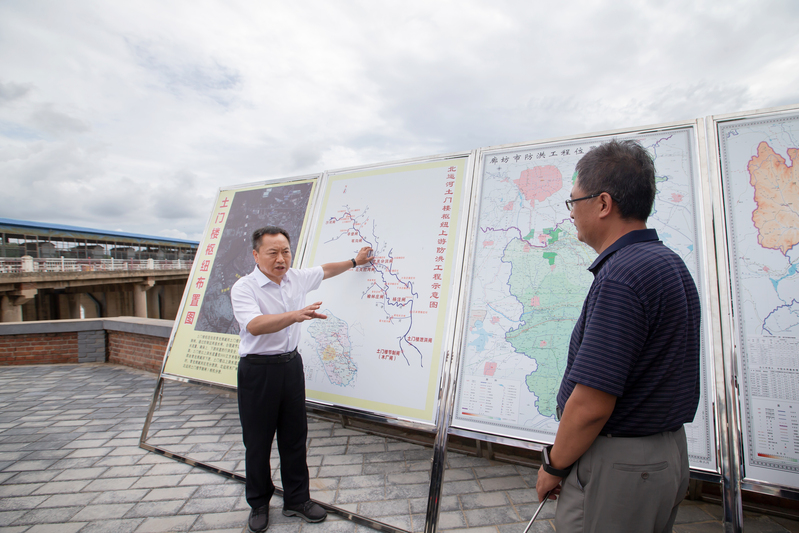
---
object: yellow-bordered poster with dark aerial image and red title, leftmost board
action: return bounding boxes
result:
[163,178,316,387]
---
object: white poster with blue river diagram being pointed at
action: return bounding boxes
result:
[300,156,476,424]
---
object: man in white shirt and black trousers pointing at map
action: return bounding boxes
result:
[230,226,372,533]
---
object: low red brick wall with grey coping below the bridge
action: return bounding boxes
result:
[0,317,174,373]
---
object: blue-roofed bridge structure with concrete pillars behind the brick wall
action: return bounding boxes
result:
[0,218,198,322]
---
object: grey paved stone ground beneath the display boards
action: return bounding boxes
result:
[0,364,799,533]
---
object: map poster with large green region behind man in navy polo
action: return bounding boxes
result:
[452,127,717,471]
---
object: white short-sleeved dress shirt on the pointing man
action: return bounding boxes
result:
[230,265,325,357]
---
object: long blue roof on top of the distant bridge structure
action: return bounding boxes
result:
[0,217,200,247]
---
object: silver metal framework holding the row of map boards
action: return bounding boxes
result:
[139,105,799,533]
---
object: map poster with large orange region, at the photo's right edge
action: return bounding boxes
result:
[716,109,799,487]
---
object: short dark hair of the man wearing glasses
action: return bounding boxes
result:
[577,139,657,222]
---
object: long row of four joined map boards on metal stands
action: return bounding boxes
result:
[142,106,799,528]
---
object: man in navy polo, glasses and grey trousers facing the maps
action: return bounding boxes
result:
[536,140,700,533]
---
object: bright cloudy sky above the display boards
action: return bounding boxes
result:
[0,0,799,239]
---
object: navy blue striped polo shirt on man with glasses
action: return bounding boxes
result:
[558,229,700,436]
